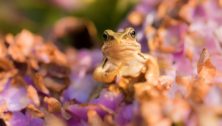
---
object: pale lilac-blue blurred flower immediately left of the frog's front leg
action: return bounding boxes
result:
[63,50,102,103]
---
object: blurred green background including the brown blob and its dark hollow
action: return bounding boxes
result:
[0,0,138,48]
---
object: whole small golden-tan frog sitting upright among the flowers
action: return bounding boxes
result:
[93,27,159,83]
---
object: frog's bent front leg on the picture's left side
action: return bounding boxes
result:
[93,59,120,83]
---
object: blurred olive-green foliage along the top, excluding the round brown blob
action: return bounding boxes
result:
[0,0,137,38]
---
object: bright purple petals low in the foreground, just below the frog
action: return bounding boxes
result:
[67,90,123,123]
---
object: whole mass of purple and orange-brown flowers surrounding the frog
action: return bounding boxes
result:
[0,0,222,126]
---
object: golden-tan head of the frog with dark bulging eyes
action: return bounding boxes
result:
[102,27,141,59]
